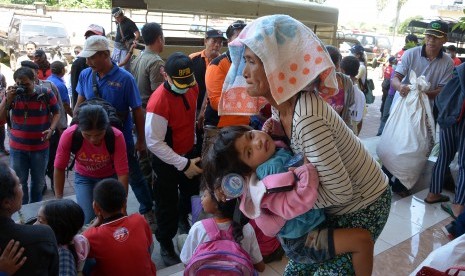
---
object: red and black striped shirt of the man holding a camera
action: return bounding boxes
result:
[9,86,58,151]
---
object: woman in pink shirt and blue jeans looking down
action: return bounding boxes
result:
[54,105,129,223]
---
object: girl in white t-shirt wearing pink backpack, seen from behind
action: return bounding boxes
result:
[179,184,265,272]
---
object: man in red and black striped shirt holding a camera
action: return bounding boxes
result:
[0,67,60,204]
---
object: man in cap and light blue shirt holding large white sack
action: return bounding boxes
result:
[385,21,454,197]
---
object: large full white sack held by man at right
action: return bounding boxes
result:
[376,71,435,189]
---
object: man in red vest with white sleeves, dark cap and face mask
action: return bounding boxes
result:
[145,52,202,266]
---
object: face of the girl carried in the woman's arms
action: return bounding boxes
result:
[234,130,276,170]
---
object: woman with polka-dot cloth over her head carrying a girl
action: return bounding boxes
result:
[220,15,391,275]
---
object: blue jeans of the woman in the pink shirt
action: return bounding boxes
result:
[74,172,116,224]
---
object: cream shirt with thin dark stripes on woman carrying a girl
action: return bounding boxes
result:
[273,92,388,215]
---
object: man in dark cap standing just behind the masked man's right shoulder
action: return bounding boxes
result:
[189,30,224,154]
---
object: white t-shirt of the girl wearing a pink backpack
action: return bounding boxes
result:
[179,221,263,264]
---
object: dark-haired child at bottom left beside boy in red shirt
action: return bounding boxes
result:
[35,199,89,276]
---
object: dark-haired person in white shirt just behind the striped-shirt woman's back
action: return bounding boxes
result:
[341,56,366,136]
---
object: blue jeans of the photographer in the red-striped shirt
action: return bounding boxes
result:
[10,148,48,204]
